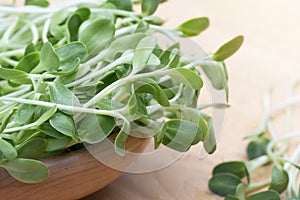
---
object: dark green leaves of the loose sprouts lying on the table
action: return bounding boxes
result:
[209,135,300,200]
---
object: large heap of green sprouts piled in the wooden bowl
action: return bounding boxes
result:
[0,0,243,183]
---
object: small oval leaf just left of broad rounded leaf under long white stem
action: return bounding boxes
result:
[49,113,77,138]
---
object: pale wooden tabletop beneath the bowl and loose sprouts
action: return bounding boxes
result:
[85,0,300,200]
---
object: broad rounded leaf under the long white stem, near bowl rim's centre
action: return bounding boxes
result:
[76,114,116,144]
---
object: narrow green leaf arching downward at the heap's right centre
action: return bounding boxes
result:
[134,79,170,107]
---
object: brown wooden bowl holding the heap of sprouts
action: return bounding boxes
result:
[0,137,149,200]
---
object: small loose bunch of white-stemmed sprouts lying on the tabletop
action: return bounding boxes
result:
[209,81,300,200]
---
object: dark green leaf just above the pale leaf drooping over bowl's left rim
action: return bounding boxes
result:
[18,137,47,159]
